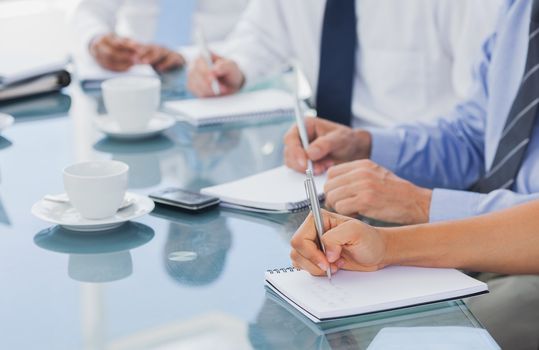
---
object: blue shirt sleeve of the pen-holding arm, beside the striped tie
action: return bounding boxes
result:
[370,30,496,189]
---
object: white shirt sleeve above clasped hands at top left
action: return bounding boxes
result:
[71,0,124,56]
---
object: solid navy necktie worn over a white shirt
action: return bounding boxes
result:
[316,0,358,125]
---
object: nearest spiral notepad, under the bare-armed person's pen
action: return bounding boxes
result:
[266,266,488,322]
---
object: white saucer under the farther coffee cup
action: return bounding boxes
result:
[95,112,176,140]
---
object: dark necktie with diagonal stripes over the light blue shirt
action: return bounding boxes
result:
[471,0,539,193]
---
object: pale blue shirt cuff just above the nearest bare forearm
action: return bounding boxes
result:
[429,188,485,222]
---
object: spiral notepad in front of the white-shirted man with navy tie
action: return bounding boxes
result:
[164,89,294,126]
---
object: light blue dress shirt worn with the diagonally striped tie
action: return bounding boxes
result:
[371,0,539,222]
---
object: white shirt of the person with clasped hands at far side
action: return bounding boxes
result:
[72,0,249,52]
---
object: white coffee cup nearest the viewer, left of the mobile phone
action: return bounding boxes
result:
[64,161,129,219]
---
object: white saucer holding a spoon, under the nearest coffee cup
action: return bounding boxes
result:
[32,192,155,232]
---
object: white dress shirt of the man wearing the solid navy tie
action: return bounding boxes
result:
[224,0,501,127]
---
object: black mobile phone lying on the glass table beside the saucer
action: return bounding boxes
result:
[150,188,221,210]
